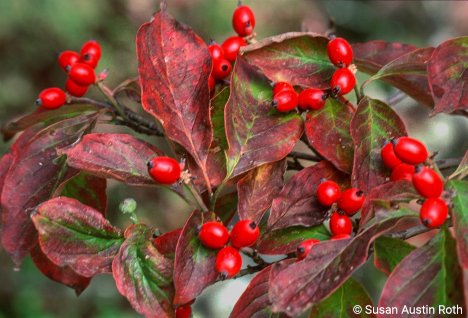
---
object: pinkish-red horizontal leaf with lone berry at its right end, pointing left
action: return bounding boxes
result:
[61,134,162,185]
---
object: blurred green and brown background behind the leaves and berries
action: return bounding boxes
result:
[0,0,468,318]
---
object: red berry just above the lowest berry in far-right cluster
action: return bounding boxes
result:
[413,166,444,198]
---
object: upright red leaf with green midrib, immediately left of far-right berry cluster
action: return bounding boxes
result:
[351,97,406,193]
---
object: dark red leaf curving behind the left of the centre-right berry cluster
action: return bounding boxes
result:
[268,161,349,230]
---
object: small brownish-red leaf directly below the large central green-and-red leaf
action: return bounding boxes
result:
[237,160,286,224]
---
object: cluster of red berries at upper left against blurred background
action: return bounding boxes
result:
[36,41,101,109]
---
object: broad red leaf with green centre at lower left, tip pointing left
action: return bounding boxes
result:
[32,197,123,277]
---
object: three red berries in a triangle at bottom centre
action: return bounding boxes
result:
[198,220,260,278]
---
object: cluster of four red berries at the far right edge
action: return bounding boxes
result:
[380,137,448,228]
